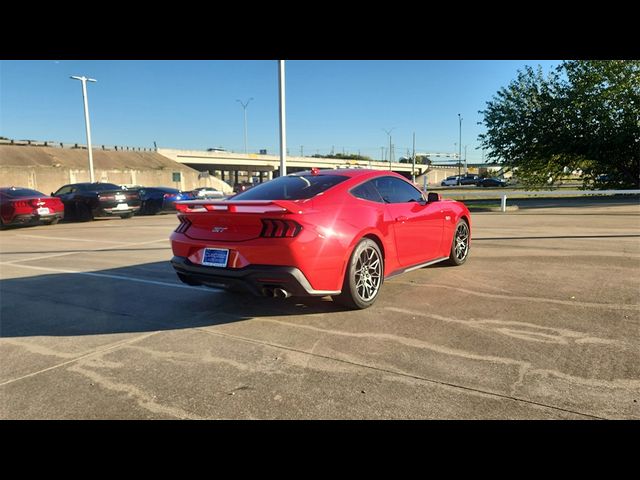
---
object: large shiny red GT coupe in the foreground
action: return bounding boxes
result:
[171,169,471,308]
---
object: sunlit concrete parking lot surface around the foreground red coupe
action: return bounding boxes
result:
[0,200,640,419]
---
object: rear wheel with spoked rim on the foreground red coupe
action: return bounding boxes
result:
[335,238,384,309]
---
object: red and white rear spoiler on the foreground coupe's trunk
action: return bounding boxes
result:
[176,199,302,213]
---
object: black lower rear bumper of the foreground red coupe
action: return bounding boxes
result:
[171,256,340,297]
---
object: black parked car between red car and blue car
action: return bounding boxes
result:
[51,183,140,221]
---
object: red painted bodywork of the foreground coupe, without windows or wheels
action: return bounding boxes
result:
[171,170,471,291]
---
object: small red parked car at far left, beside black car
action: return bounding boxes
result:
[0,187,64,226]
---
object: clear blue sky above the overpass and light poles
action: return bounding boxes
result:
[0,60,560,162]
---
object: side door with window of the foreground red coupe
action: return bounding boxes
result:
[373,176,444,267]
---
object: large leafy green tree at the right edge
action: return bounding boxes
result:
[480,60,640,188]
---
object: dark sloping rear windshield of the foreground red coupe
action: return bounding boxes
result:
[233,175,349,200]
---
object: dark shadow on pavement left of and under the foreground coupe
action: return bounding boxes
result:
[0,261,347,338]
